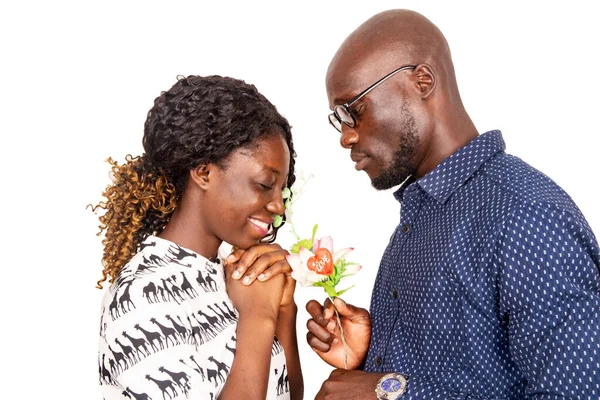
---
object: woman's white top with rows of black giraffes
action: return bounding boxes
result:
[98,236,289,400]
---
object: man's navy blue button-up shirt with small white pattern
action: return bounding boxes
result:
[364,131,600,400]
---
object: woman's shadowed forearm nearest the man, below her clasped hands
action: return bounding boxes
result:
[275,302,304,400]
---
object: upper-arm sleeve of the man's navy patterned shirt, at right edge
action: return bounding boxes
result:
[495,206,600,399]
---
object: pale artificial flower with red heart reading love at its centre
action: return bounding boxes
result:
[286,230,362,297]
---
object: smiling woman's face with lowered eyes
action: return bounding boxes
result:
[204,134,290,249]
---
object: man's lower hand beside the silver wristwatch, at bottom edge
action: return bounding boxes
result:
[315,369,386,400]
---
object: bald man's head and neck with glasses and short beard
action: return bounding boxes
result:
[326,10,478,189]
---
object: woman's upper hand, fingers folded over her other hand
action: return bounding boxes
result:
[225,243,296,307]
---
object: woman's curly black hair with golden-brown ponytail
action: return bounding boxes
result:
[92,75,296,288]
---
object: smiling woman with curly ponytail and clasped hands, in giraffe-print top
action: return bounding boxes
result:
[97,76,303,400]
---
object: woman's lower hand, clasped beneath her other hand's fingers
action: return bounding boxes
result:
[224,264,285,321]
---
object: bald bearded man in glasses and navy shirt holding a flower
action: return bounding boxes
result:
[306,10,600,400]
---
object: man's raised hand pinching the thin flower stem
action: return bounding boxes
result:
[306,297,371,369]
